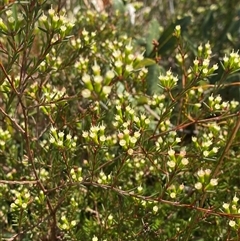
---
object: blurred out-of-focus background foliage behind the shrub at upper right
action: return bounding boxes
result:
[39,0,240,97]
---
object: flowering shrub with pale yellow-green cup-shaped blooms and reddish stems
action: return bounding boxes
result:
[0,1,240,241]
